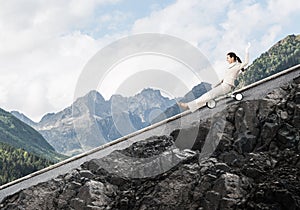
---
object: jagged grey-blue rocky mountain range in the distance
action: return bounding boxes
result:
[12,88,180,156]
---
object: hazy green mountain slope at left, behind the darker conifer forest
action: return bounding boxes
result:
[0,109,66,162]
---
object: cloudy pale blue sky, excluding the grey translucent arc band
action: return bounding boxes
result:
[0,0,300,121]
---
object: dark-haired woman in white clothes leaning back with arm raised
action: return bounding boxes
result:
[178,43,250,112]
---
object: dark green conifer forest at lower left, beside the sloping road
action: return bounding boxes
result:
[0,142,54,185]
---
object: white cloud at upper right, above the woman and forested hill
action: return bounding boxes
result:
[132,0,300,79]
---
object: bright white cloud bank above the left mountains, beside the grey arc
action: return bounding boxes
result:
[0,32,127,121]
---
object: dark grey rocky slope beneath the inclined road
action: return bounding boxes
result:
[0,77,300,210]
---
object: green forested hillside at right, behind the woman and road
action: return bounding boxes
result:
[238,35,300,88]
